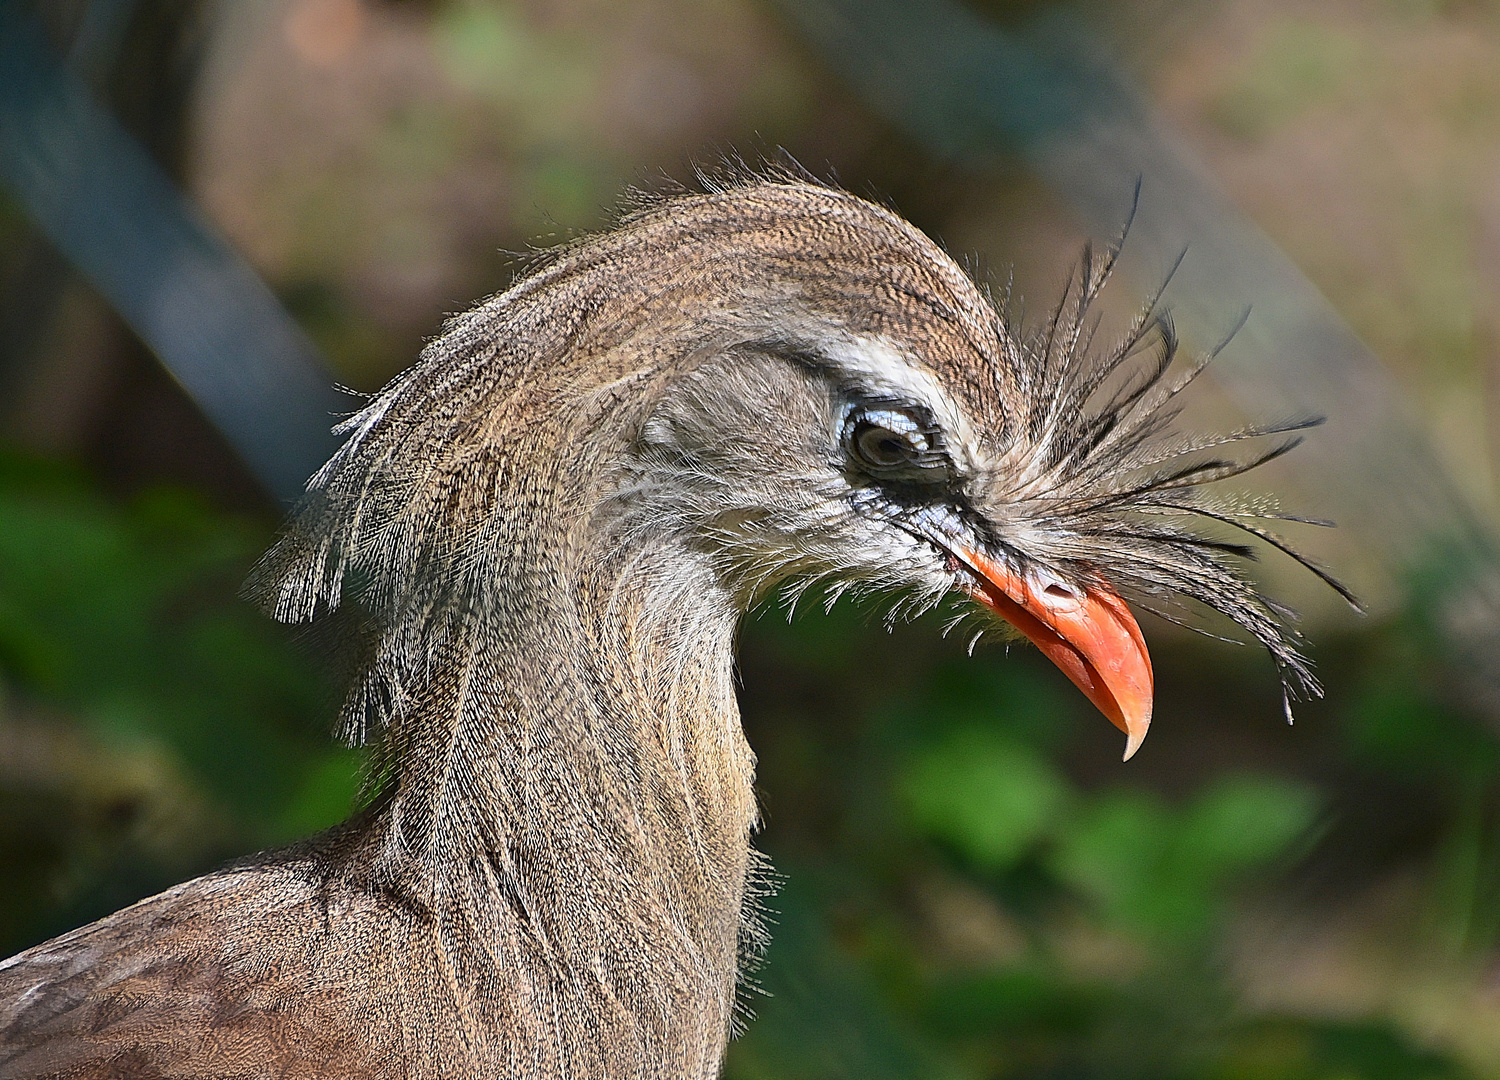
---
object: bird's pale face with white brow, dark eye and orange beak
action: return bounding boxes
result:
[621,336,1152,756]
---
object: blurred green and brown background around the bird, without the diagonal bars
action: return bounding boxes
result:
[0,0,1500,1080]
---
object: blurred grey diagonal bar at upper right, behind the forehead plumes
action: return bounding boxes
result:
[779,0,1500,600]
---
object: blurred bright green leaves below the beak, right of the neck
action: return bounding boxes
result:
[728,600,1500,1080]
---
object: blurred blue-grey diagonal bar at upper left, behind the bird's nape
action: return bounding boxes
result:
[0,0,350,503]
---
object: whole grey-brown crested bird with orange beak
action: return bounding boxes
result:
[0,179,1344,1080]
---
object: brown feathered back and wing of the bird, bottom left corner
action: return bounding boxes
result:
[0,864,404,1080]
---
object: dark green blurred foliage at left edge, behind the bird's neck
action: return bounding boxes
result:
[0,455,359,945]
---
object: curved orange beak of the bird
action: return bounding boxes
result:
[956,549,1154,761]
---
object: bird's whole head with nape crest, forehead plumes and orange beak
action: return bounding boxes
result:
[261,182,1347,758]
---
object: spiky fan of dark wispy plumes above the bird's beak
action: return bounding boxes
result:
[966,234,1359,720]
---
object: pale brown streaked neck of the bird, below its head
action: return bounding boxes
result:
[343,516,755,1076]
